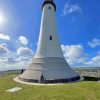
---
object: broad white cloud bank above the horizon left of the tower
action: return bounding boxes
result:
[0,41,33,71]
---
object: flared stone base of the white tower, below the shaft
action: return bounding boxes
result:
[18,58,81,84]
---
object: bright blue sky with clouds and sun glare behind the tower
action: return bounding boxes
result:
[0,0,100,70]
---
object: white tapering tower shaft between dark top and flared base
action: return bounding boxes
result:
[35,4,63,58]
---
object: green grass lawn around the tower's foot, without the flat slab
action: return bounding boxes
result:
[0,74,100,100]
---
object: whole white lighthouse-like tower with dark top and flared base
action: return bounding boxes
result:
[19,0,80,83]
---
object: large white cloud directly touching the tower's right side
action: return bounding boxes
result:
[61,45,87,66]
